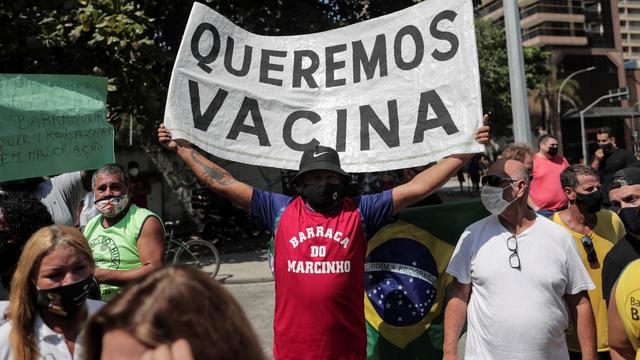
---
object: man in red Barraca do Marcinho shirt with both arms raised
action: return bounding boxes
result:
[158,121,489,359]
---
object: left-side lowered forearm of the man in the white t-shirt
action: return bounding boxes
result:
[443,279,471,360]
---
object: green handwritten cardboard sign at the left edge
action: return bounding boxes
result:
[0,74,114,181]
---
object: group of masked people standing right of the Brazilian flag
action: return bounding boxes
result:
[444,128,640,359]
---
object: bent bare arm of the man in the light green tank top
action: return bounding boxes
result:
[94,216,165,286]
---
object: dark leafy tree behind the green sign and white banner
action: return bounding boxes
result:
[0,0,335,146]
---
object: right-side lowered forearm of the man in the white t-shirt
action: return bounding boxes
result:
[565,290,597,360]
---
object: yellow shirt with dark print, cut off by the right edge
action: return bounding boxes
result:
[615,260,640,359]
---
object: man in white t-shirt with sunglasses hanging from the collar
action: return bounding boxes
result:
[444,160,596,360]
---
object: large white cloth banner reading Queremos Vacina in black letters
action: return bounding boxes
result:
[165,0,484,172]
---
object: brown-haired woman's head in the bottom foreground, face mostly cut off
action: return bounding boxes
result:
[85,266,264,360]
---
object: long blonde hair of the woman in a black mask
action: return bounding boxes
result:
[7,225,95,360]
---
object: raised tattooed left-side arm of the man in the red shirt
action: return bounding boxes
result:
[158,124,253,212]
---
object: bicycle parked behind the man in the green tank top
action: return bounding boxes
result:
[164,221,220,277]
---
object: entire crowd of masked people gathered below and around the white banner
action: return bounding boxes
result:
[0,119,640,359]
